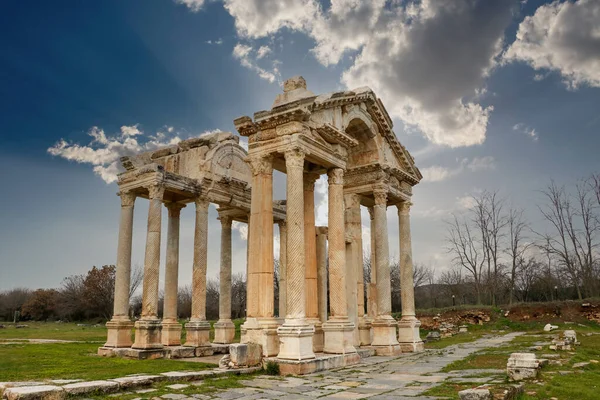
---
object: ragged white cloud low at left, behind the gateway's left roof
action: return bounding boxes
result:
[47,124,218,183]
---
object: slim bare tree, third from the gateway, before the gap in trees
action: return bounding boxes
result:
[506,208,531,305]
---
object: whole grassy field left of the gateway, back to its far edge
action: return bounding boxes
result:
[0,320,243,381]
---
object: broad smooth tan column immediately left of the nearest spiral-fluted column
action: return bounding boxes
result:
[241,156,279,357]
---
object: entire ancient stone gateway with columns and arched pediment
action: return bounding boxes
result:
[100,77,423,372]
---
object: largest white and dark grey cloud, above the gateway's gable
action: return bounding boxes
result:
[213,0,513,147]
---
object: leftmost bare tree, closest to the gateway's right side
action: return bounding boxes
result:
[446,214,485,304]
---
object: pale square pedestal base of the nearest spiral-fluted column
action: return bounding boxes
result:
[277,320,315,361]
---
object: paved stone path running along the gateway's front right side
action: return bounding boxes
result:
[130,332,522,400]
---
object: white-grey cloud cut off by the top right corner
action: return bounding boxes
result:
[504,0,600,89]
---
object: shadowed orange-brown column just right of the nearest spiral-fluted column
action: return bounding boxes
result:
[304,173,324,353]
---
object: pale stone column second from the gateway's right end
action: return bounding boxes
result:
[371,190,400,355]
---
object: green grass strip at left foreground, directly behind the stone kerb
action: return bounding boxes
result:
[0,343,215,381]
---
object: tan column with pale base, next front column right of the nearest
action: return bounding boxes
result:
[323,168,356,354]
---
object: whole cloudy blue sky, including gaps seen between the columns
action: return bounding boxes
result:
[0,0,600,290]
